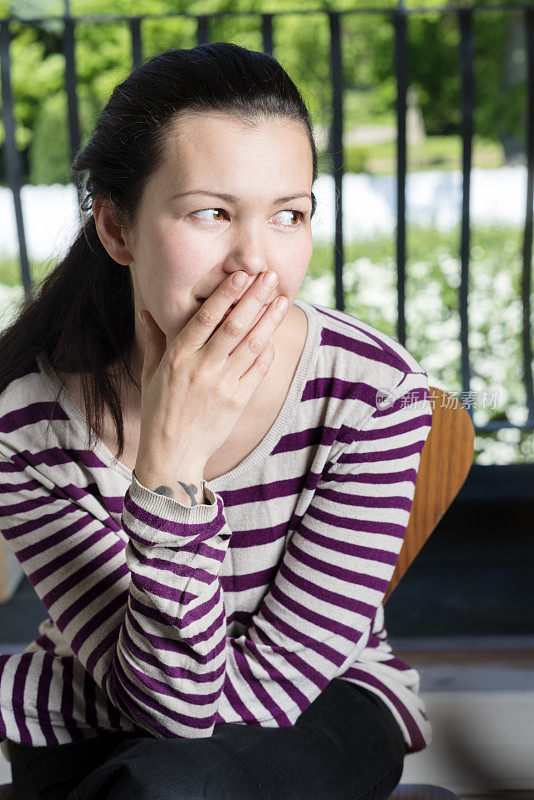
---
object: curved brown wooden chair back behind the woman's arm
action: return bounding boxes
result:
[382,386,475,605]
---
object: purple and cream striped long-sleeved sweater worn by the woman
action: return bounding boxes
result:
[0,300,432,753]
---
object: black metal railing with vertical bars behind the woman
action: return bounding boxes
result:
[0,0,534,432]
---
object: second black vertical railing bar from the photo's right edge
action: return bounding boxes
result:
[458,8,474,417]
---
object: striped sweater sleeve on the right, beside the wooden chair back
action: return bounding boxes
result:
[216,372,432,727]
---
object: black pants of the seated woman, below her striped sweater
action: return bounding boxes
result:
[8,678,406,800]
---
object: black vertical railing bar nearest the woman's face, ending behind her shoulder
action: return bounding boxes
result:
[328,12,345,311]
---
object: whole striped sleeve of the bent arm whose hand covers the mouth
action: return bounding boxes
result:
[0,454,231,738]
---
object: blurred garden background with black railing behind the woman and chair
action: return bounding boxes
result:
[0,0,534,800]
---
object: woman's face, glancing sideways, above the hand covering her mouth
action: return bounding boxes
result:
[122,112,313,363]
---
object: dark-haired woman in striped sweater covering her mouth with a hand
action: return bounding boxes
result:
[0,43,431,800]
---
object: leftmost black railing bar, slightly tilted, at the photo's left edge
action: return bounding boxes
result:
[0,20,32,298]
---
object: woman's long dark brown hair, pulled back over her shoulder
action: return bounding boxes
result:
[0,42,317,459]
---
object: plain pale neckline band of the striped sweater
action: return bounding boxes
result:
[37,299,320,492]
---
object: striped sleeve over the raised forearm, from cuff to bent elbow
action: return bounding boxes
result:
[105,468,231,738]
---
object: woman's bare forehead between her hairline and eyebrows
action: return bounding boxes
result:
[153,112,313,194]
